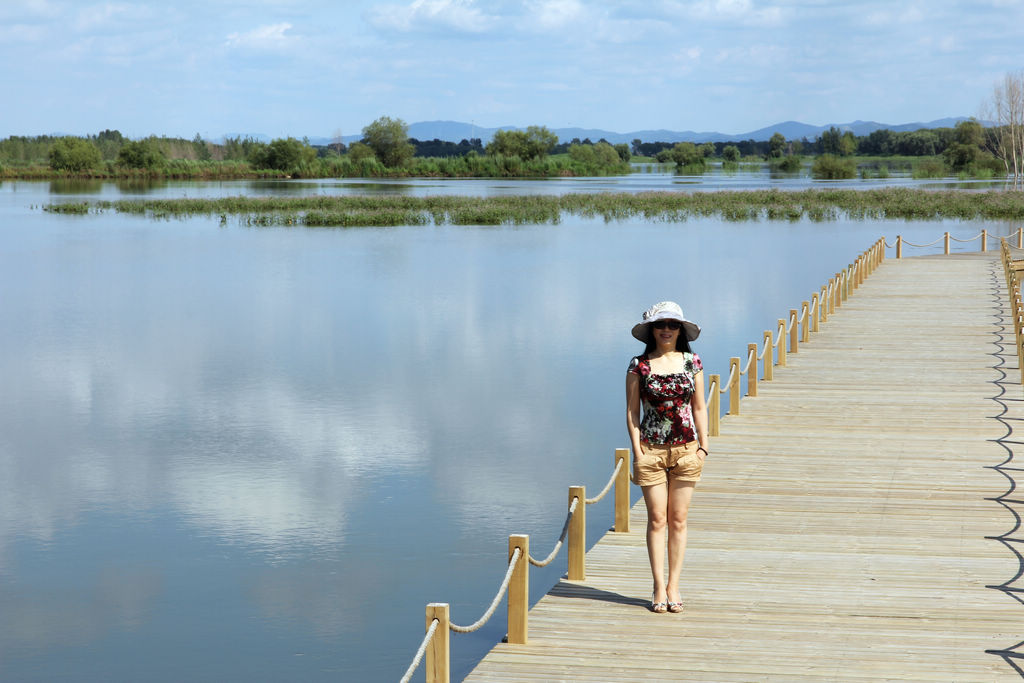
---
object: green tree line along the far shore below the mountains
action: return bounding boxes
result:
[0,66,1024,184]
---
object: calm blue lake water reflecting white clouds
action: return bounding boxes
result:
[0,169,1017,681]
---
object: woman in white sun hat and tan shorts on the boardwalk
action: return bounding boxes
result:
[626,301,708,613]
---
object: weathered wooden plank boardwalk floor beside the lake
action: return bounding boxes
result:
[466,252,1024,682]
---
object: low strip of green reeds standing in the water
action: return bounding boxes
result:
[43,187,1024,227]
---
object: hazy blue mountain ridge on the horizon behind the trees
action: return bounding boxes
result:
[225,117,978,145]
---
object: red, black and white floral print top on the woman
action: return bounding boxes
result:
[627,353,703,445]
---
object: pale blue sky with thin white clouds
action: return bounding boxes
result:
[0,0,1024,139]
